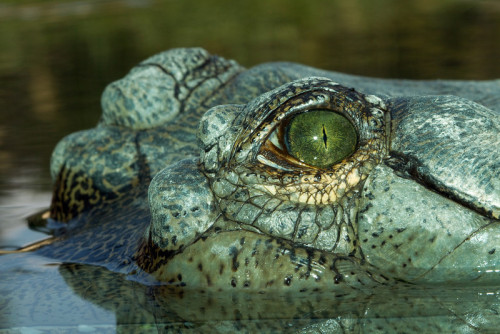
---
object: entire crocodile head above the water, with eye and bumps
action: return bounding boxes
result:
[33,49,500,290]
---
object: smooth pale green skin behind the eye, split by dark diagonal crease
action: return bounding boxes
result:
[358,96,500,284]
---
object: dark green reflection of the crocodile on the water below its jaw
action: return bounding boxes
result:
[59,264,500,333]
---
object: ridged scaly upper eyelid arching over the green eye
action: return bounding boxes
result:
[228,82,366,172]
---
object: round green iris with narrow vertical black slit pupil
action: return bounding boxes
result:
[284,110,358,168]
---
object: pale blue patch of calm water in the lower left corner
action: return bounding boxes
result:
[0,253,116,333]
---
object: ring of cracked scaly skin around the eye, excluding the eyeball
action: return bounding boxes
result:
[200,78,386,254]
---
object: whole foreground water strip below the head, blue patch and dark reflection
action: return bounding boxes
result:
[4,254,500,333]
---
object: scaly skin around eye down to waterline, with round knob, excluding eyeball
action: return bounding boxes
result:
[137,78,393,289]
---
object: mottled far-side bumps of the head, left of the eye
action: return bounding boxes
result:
[51,49,243,222]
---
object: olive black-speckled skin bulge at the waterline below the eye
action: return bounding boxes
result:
[142,231,397,291]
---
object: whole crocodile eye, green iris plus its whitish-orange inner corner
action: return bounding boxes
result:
[261,109,358,169]
